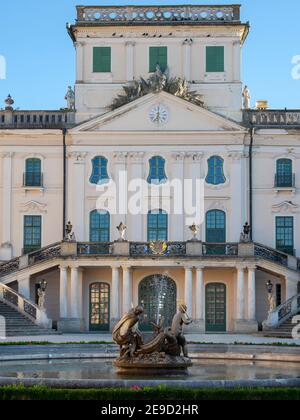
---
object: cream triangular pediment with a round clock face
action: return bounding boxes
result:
[71,92,245,133]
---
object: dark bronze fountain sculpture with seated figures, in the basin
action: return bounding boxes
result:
[113,305,192,375]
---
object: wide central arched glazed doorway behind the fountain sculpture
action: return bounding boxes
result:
[139,274,177,331]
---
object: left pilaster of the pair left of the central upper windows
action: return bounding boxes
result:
[111,152,130,240]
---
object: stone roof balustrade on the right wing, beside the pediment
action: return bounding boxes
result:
[243,109,300,128]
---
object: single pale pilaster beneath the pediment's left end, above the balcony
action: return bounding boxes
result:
[68,152,88,241]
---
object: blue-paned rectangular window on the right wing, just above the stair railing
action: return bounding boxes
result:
[276,216,294,255]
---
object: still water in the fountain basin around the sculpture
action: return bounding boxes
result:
[0,359,300,380]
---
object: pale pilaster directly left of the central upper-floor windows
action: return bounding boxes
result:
[127,152,146,242]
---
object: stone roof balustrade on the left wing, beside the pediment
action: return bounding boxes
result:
[0,110,75,129]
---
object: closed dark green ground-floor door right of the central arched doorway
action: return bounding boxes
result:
[205,283,226,332]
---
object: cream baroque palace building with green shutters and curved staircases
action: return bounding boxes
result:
[0,5,300,335]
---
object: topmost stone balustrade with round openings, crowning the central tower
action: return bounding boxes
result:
[77,5,240,24]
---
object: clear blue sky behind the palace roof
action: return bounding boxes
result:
[0,0,300,109]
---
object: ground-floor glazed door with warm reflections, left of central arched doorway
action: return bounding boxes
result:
[89,283,110,331]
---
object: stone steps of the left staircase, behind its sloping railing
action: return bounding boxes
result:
[0,301,57,337]
